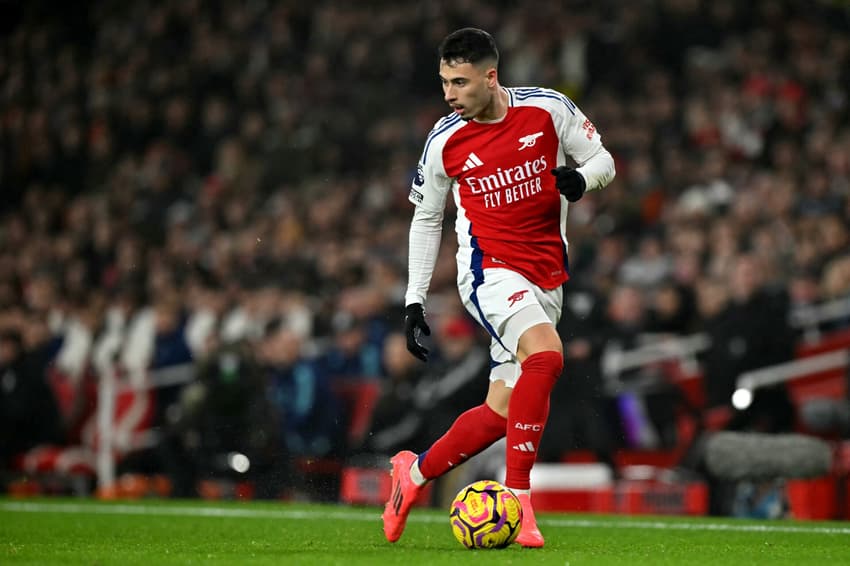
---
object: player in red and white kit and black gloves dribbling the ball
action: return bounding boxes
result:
[383,28,614,547]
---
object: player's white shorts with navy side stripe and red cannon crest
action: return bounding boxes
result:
[458,268,564,387]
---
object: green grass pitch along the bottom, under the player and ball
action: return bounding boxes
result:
[0,499,850,566]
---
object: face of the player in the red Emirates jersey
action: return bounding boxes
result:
[440,60,498,120]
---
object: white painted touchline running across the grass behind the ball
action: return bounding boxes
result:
[0,501,850,535]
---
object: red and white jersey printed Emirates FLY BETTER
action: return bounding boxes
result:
[409,88,613,289]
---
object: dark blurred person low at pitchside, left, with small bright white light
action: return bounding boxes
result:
[155,335,282,498]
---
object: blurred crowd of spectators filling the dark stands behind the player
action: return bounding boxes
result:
[0,0,850,492]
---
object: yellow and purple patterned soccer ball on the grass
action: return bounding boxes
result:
[449,480,522,548]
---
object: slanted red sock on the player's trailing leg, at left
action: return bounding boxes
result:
[419,404,507,479]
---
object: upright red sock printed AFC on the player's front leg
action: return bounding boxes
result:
[505,351,564,489]
